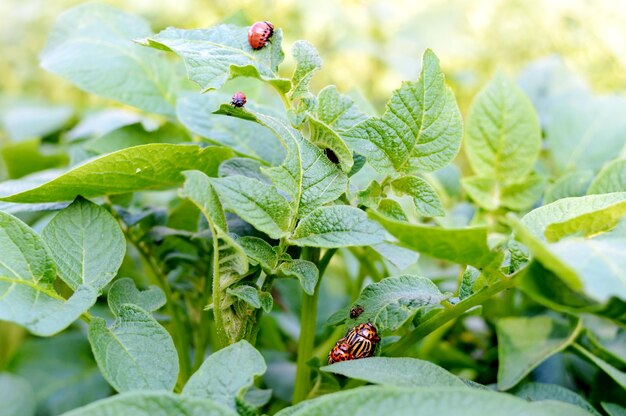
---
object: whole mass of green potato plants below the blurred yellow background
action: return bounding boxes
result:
[0,4,626,415]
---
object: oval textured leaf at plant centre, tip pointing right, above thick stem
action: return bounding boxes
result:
[290,205,385,248]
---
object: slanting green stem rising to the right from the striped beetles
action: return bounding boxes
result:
[384,275,515,356]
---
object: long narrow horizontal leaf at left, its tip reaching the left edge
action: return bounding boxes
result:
[0,144,233,202]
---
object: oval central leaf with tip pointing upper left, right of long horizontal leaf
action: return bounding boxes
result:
[211,176,291,238]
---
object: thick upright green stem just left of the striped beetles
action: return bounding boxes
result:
[293,247,337,403]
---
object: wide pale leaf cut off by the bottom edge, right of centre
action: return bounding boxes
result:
[277,386,589,416]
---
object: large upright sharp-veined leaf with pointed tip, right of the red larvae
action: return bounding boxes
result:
[343,50,463,173]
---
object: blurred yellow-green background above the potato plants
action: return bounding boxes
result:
[0,0,626,114]
